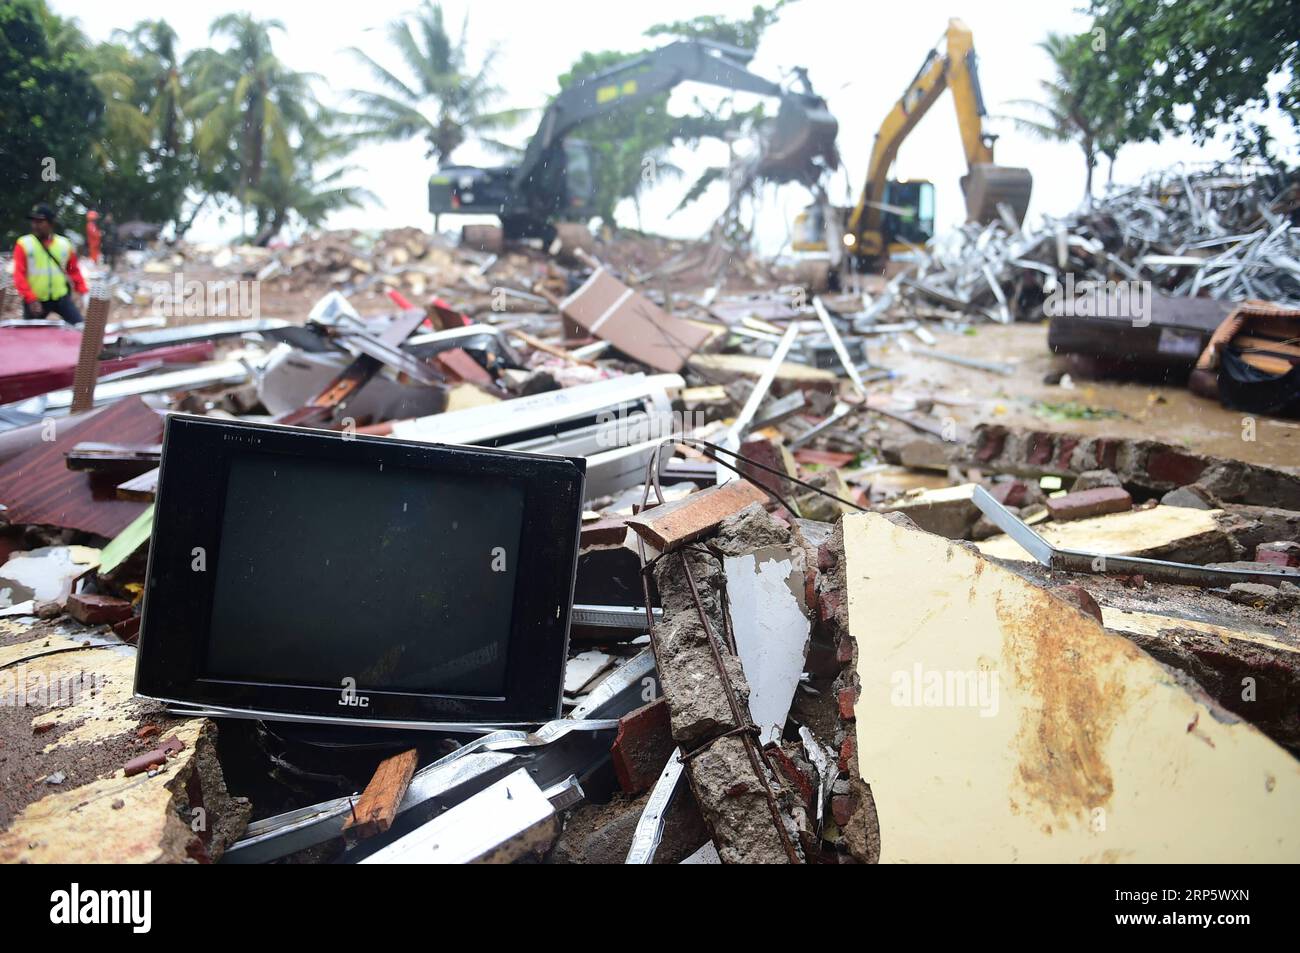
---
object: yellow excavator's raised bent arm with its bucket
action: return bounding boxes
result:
[846,18,1032,257]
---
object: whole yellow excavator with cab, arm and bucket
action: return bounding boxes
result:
[792,20,1034,282]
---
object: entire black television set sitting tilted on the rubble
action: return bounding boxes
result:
[137,415,584,727]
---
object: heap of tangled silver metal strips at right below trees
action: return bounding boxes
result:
[867,163,1300,322]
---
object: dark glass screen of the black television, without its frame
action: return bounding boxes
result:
[207,455,524,694]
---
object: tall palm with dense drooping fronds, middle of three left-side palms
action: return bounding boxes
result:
[183,13,319,204]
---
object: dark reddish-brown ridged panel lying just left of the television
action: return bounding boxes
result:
[0,397,163,538]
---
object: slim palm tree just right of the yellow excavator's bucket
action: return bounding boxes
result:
[1010,33,1122,200]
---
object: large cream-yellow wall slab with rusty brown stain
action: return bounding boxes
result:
[844,514,1300,862]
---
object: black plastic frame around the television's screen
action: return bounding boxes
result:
[135,415,586,728]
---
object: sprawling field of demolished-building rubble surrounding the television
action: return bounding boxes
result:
[0,208,1300,863]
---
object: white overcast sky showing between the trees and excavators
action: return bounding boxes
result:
[51,0,1296,252]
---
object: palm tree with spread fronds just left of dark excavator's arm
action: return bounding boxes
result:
[347,0,529,164]
